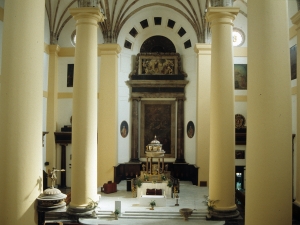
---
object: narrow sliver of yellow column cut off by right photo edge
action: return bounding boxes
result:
[291,11,300,214]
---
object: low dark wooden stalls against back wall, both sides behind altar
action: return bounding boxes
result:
[114,162,199,185]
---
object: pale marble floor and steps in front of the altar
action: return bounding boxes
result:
[79,180,225,225]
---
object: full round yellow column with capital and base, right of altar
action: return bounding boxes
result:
[207,7,239,218]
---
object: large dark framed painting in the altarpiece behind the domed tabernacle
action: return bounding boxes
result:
[140,101,175,158]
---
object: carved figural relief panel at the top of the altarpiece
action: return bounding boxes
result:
[139,55,178,75]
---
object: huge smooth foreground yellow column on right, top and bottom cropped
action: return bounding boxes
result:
[245,0,292,225]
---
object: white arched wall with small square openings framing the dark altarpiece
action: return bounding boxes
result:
[118,7,197,164]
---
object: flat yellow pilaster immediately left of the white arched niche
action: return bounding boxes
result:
[98,44,121,186]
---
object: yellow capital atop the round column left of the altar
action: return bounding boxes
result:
[69,7,104,22]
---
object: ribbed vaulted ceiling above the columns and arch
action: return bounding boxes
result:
[46,0,247,44]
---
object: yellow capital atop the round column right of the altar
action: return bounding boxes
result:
[206,7,240,26]
